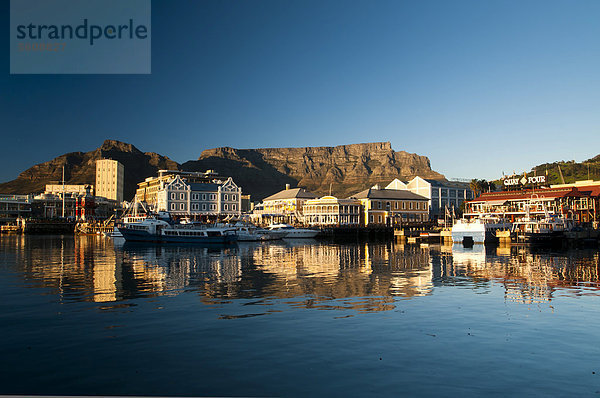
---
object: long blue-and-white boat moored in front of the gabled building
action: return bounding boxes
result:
[119,218,237,244]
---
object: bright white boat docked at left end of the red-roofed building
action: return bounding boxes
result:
[452,215,512,243]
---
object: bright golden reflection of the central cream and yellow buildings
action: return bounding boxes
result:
[227,242,432,309]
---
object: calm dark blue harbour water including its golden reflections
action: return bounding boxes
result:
[0,236,600,397]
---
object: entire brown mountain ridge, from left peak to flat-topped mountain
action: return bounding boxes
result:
[0,139,445,200]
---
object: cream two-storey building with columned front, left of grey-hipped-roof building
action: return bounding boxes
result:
[303,196,361,226]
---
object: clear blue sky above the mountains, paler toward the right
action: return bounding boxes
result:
[0,0,600,181]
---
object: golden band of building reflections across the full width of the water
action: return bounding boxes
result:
[0,236,599,311]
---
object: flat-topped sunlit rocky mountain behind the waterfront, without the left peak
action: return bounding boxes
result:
[181,142,444,200]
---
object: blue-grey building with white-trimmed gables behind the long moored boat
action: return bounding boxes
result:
[156,175,242,216]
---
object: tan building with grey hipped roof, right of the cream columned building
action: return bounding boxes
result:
[350,182,429,226]
